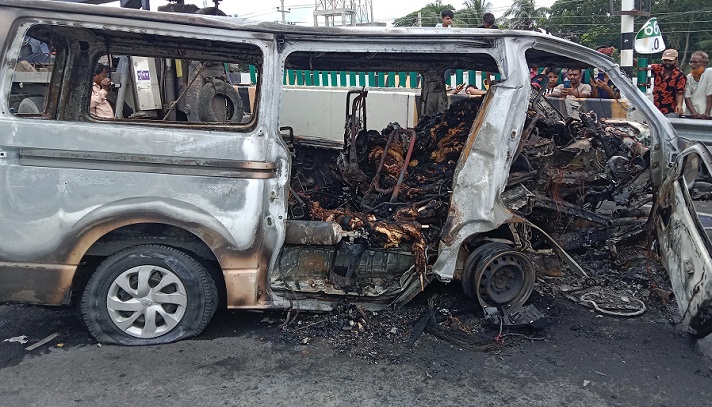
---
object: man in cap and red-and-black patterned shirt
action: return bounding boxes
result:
[650,49,687,116]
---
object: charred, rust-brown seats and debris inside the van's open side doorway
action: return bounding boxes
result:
[290,95,481,286]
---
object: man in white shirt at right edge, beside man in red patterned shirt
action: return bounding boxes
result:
[685,51,712,119]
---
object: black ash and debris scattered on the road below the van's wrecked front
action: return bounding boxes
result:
[272,249,678,363]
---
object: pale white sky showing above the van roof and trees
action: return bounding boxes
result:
[115,0,554,25]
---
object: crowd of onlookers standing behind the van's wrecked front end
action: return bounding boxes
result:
[437,10,712,119]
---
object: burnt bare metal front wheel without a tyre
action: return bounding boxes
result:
[462,243,536,307]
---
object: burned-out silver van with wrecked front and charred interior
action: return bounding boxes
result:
[0,0,712,345]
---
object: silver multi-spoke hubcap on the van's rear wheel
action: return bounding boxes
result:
[106,265,188,338]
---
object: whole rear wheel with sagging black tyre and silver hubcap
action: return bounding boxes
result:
[81,245,218,345]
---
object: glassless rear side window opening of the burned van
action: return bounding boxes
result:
[10,24,263,130]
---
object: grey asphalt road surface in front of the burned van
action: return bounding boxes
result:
[0,292,712,407]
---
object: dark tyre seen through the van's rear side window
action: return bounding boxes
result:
[198,79,244,123]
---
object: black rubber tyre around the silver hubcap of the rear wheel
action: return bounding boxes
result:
[80,245,218,346]
